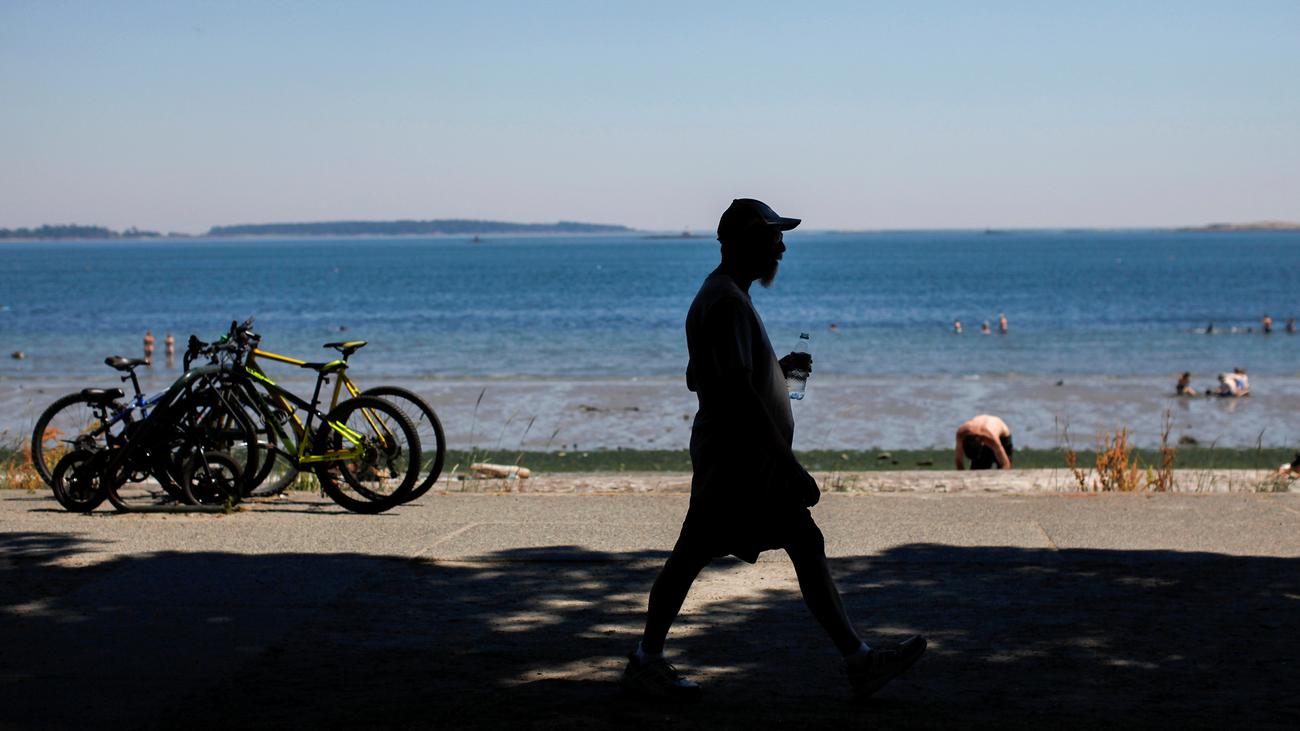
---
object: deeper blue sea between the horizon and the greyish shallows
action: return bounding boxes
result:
[0,230,1300,380]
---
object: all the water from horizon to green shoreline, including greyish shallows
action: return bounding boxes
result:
[0,230,1300,447]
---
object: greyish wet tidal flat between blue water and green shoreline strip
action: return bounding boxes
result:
[0,368,1300,451]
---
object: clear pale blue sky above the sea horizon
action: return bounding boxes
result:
[0,0,1300,232]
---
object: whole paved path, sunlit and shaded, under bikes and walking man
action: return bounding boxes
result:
[0,490,1300,728]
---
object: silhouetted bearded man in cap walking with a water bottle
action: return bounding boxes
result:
[620,198,926,700]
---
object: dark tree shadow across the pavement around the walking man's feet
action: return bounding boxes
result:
[0,533,1300,728]
